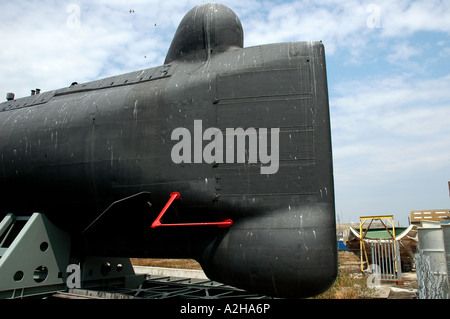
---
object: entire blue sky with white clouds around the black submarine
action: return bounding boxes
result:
[0,0,450,225]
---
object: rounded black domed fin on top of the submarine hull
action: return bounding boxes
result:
[164,3,244,64]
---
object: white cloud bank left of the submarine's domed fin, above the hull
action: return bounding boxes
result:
[0,1,200,97]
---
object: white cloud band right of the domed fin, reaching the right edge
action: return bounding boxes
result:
[244,0,450,64]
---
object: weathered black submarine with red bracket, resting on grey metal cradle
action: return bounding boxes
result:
[0,3,337,298]
